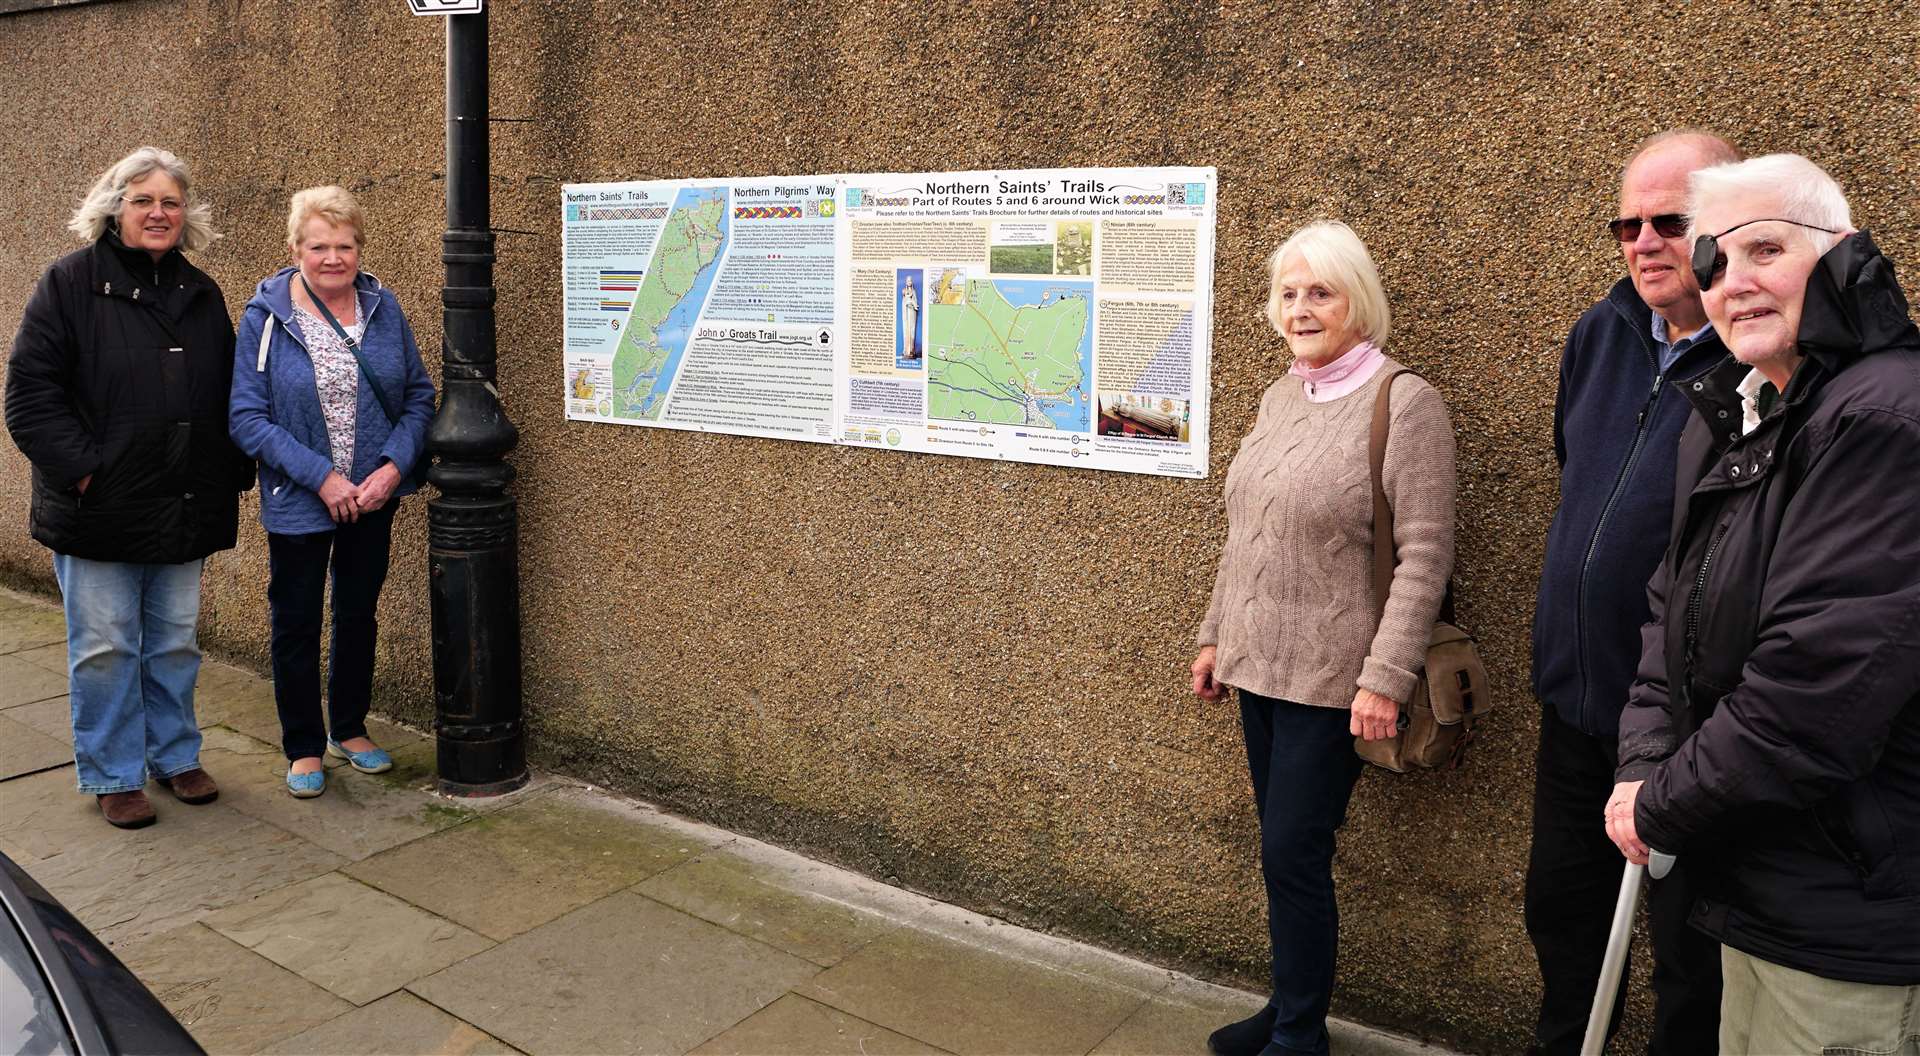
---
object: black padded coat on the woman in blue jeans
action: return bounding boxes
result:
[6,232,253,564]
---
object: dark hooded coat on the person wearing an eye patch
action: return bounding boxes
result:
[1619,232,1920,985]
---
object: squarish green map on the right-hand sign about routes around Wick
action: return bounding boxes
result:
[927,282,1092,432]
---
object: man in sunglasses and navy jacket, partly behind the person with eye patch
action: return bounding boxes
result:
[1524,129,1740,1054]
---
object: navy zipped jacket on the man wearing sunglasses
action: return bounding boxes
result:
[1534,278,1726,739]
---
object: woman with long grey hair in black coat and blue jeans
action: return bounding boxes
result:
[6,146,252,828]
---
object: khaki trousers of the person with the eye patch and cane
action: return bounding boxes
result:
[1720,947,1920,1056]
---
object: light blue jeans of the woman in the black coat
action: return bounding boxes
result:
[54,553,204,795]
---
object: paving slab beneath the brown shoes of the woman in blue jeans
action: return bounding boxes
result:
[0,791,346,947]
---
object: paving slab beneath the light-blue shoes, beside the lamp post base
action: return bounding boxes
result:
[200,726,480,862]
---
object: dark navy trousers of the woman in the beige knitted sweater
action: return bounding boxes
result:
[1240,689,1361,1054]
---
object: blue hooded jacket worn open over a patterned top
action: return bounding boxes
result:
[227,267,434,536]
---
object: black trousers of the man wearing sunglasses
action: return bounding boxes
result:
[1526,705,1720,1056]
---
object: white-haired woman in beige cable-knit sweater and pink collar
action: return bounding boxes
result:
[1192,221,1453,1056]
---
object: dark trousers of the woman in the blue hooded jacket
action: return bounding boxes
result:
[267,501,399,760]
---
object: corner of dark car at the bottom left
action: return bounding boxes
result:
[0,854,204,1056]
